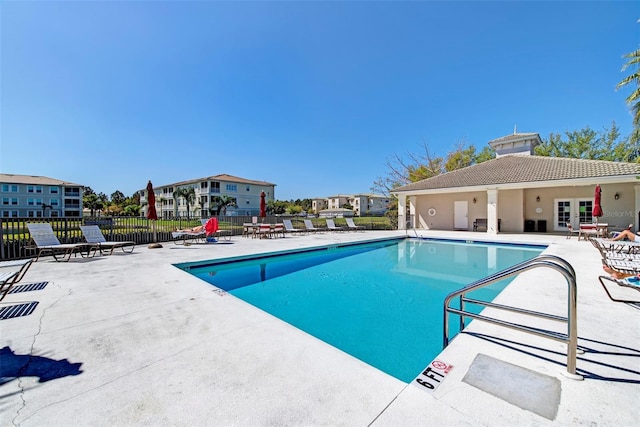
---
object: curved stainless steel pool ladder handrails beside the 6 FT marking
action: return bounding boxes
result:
[443,255,582,380]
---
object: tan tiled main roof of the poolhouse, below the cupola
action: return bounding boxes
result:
[393,156,640,192]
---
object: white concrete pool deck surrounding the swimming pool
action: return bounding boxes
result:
[0,231,640,426]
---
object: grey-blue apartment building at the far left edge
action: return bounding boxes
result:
[0,174,84,218]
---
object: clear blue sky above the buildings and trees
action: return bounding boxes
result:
[0,1,640,200]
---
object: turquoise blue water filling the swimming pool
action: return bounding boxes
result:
[178,239,544,382]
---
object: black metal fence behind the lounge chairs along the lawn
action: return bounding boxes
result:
[0,216,393,260]
